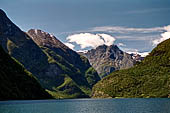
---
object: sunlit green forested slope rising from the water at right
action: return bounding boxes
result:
[92,39,170,98]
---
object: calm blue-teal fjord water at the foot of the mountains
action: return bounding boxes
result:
[0,98,170,113]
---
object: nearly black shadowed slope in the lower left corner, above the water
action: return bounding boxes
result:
[0,46,52,100]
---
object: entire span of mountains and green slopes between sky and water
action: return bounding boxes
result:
[0,9,170,100]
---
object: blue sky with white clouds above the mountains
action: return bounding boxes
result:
[0,0,170,53]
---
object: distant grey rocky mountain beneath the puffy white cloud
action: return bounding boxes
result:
[80,45,135,78]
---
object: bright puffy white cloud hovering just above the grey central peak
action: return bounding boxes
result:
[67,33,115,49]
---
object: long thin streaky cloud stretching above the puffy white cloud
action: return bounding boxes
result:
[58,26,165,36]
